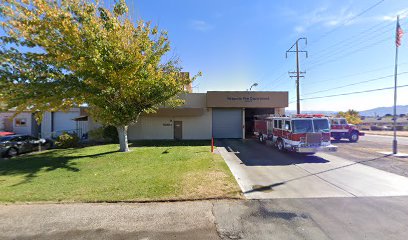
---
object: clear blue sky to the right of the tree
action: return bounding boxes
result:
[125,0,408,111]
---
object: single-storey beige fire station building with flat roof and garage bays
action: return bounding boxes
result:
[111,91,288,140]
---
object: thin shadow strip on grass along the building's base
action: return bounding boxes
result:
[129,140,211,147]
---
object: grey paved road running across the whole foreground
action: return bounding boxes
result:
[0,197,408,240]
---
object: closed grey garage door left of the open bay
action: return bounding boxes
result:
[212,108,242,138]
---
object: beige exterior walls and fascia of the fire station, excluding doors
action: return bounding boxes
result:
[84,92,288,140]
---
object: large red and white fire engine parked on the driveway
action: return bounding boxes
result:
[254,114,337,154]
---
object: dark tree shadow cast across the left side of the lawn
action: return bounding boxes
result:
[0,149,117,186]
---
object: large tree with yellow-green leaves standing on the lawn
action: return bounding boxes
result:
[0,0,195,151]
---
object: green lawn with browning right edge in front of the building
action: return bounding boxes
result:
[0,141,240,202]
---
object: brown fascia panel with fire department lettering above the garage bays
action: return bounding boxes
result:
[207,91,288,108]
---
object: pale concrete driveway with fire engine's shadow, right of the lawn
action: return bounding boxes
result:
[216,140,408,199]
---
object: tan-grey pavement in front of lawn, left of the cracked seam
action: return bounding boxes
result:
[0,201,219,240]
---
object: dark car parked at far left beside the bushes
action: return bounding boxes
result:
[0,135,52,157]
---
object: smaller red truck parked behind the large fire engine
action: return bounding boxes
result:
[330,118,364,142]
